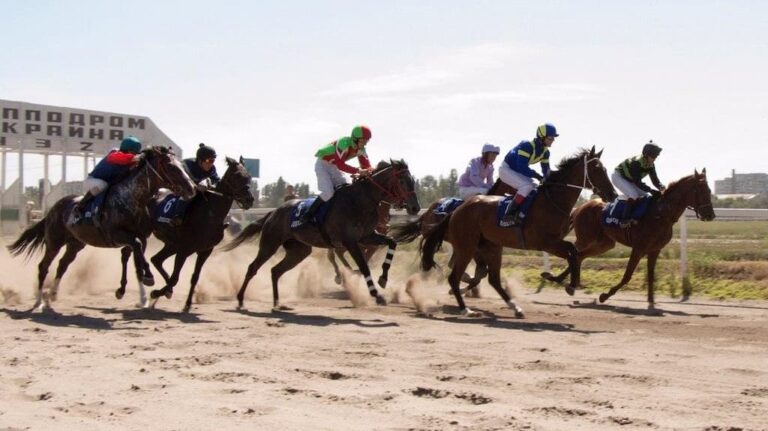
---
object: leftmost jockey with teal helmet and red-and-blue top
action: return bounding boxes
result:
[74,136,143,218]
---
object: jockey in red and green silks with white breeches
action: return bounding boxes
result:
[301,125,373,223]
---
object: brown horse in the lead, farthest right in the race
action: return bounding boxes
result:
[541,169,715,310]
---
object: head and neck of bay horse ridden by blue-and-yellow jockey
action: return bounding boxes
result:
[545,146,618,202]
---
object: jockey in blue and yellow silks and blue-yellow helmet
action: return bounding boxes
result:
[499,123,559,224]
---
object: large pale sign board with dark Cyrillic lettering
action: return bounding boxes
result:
[0,100,181,157]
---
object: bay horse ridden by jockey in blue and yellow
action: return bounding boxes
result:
[420,147,616,318]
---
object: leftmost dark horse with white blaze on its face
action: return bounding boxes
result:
[8,147,196,311]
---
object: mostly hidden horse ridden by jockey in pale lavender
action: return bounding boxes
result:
[391,179,517,296]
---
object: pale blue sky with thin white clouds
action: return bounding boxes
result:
[0,0,768,189]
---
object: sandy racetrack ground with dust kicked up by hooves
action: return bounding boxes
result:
[0,240,768,431]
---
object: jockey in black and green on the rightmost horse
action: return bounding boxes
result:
[611,141,665,227]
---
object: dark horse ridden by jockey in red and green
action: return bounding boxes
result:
[224,160,420,311]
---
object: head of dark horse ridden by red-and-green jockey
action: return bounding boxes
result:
[371,160,421,215]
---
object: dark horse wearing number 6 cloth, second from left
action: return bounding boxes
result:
[142,157,253,313]
